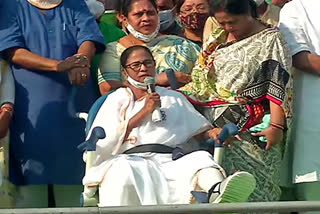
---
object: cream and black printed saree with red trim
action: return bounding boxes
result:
[181,25,293,201]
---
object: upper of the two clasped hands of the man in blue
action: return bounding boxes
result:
[57,54,90,72]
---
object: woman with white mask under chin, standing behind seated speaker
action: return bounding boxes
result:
[98,0,200,94]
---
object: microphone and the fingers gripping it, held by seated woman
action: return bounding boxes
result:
[144,77,162,122]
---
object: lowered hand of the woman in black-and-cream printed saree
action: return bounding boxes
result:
[252,126,283,150]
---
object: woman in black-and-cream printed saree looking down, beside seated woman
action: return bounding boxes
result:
[182,0,292,201]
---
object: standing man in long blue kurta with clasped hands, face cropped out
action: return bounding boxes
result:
[0,0,104,207]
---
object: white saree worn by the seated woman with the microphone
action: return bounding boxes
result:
[83,87,220,206]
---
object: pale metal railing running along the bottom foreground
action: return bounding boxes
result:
[0,201,320,214]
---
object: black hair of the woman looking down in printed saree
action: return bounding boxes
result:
[211,0,258,18]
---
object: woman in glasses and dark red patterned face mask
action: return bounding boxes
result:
[177,0,210,47]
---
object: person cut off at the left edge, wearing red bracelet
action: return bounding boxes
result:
[0,58,15,209]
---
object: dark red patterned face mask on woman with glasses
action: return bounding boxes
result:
[179,13,209,30]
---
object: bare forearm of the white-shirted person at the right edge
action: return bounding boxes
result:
[293,51,320,75]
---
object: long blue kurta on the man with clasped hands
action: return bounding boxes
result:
[0,0,104,185]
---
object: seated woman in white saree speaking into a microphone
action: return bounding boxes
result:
[83,46,255,206]
